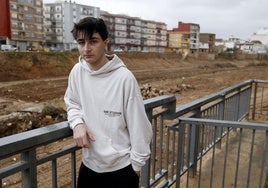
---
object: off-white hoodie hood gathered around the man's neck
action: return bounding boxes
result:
[79,54,125,76]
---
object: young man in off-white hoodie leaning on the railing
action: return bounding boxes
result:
[64,17,152,188]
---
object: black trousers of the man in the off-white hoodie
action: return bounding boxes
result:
[77,163,139,188]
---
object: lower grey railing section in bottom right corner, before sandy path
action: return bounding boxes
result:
[168,118,268,188]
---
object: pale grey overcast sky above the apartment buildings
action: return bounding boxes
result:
[43,0,268,40]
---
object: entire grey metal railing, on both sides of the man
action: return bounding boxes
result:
[0,80,268,188]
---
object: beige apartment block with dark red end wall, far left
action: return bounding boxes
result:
[0,0,45,51]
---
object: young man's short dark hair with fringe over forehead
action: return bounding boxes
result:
[71,17,108,40]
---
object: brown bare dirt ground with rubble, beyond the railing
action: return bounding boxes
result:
[0,53,268,188]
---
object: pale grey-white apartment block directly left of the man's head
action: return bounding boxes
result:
[44,1,100,51]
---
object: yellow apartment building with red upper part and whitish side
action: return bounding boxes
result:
[168,21,200,53]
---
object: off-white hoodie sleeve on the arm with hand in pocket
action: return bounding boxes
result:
[126,76,152,171]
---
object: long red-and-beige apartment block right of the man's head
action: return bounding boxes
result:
[101,11,167,52]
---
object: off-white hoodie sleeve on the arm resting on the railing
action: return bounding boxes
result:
[64,65,84,129]
